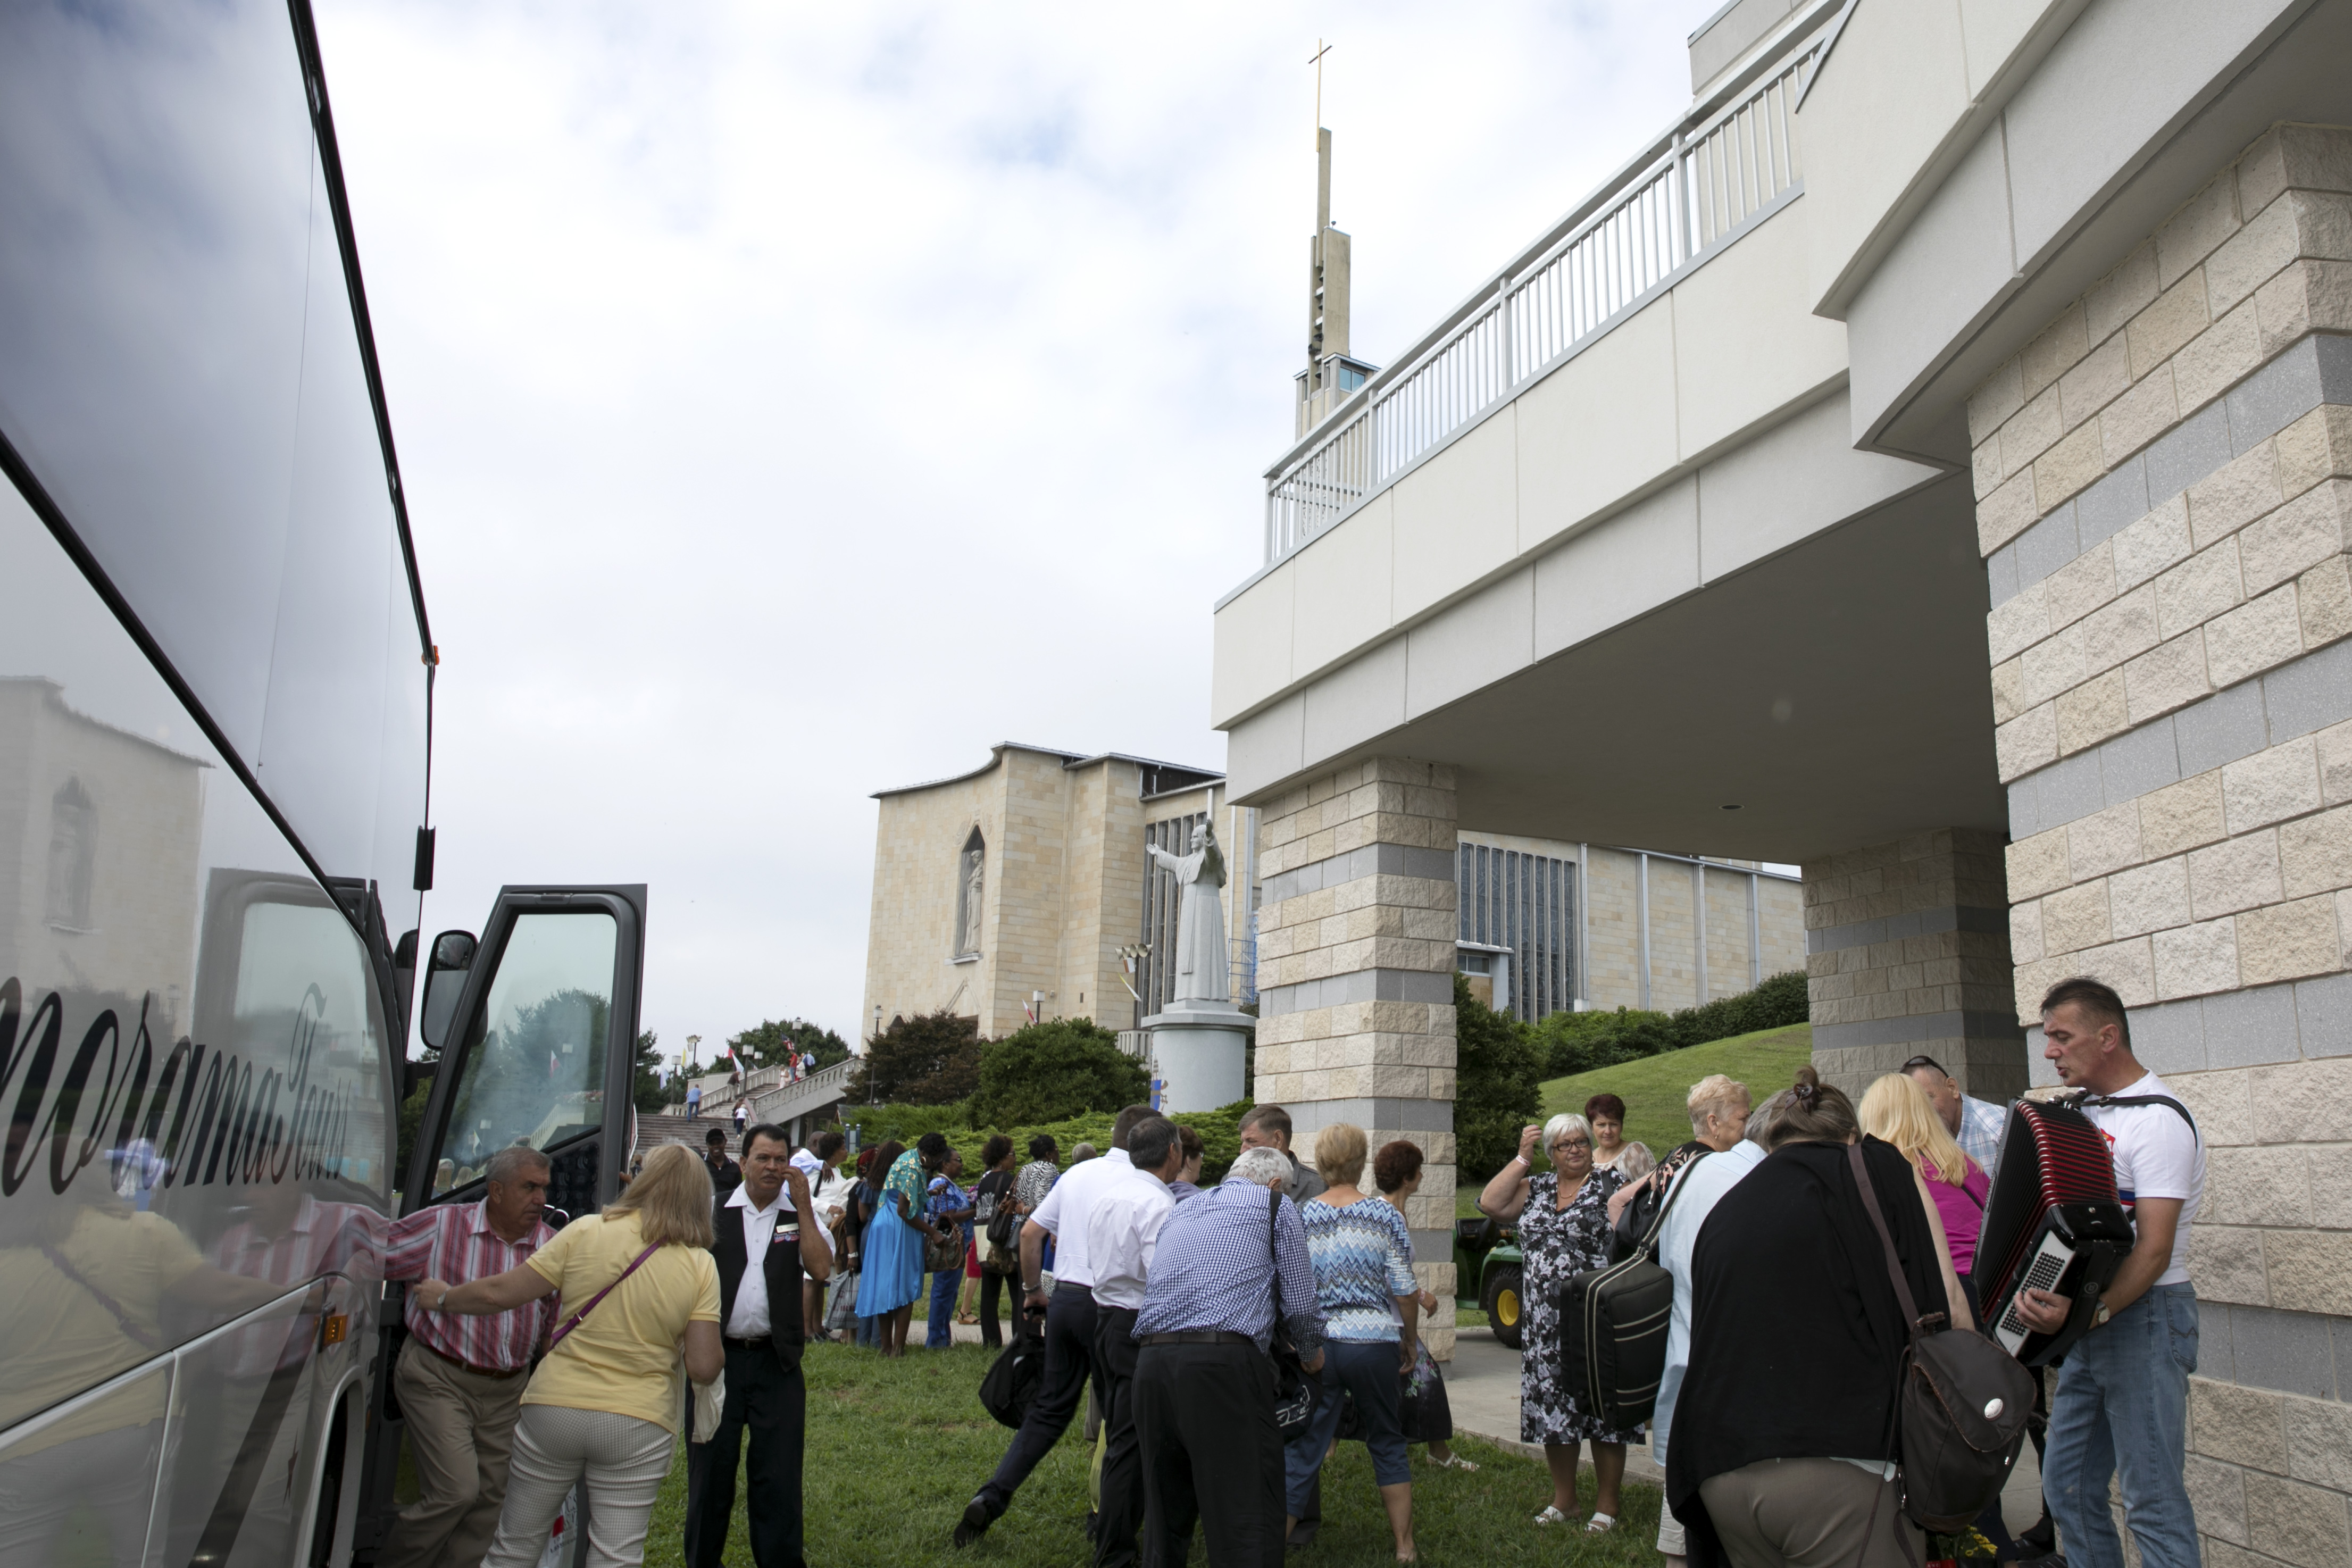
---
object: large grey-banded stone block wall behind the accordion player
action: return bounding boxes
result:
[1966,124,2352,1568]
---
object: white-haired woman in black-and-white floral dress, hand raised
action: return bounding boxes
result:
[1477,1116,1639,1535]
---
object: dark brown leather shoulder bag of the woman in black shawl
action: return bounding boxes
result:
[1846,1145,2034,1533]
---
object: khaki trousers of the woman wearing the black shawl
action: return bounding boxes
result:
[1698,1460,1926,1568]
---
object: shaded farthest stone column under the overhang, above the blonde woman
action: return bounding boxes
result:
[1797,828,2025,1100]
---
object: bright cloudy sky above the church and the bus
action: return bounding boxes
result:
[318,0,1717,1055]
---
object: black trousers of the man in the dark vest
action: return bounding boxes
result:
[687,1340,809,1568]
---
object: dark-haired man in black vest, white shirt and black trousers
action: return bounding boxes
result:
[687,1121,832,1568]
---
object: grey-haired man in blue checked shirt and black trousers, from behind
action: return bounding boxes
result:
[1133,1149,1322,1568]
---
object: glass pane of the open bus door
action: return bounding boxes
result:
[433,910,619,1199]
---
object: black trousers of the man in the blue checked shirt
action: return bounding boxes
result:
[1129,1340,1282,1568]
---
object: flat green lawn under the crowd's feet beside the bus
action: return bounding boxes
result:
[645,1345,1661,1568]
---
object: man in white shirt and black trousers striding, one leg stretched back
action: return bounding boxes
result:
[950,1105,1157,1547]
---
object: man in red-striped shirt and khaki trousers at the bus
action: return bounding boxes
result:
[377,1145,555,1568]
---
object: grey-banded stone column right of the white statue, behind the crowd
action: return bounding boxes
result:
[1252,757,1456,1361]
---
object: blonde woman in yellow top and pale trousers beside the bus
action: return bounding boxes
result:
[416,1142,727,1568]
